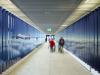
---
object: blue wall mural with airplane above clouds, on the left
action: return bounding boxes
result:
[0,7,45,73]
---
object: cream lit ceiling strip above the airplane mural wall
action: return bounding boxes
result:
[0,0,43,32]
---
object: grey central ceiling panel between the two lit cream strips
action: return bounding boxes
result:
[11,0,82,34]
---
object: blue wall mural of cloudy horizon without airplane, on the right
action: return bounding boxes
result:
[56,7,100,72]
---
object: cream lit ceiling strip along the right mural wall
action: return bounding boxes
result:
[57,0,100,32]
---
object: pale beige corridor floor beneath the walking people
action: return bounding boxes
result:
[9,43,92,75]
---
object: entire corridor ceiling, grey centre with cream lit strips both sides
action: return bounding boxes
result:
[1,0,100,34]
